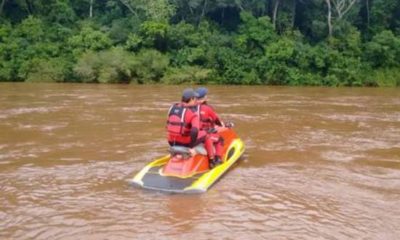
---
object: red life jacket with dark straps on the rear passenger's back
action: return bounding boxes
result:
[167,103,191,136]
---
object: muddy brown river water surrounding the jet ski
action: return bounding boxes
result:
[0,83,400,239]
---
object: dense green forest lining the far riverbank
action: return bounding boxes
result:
[0,0,400,86]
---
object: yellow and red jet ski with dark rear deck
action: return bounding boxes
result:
[130,127,244,193]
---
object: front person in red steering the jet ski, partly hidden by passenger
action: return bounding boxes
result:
[196,87,224,166]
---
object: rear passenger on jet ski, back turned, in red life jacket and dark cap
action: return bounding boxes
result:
[167,89,214,162]
